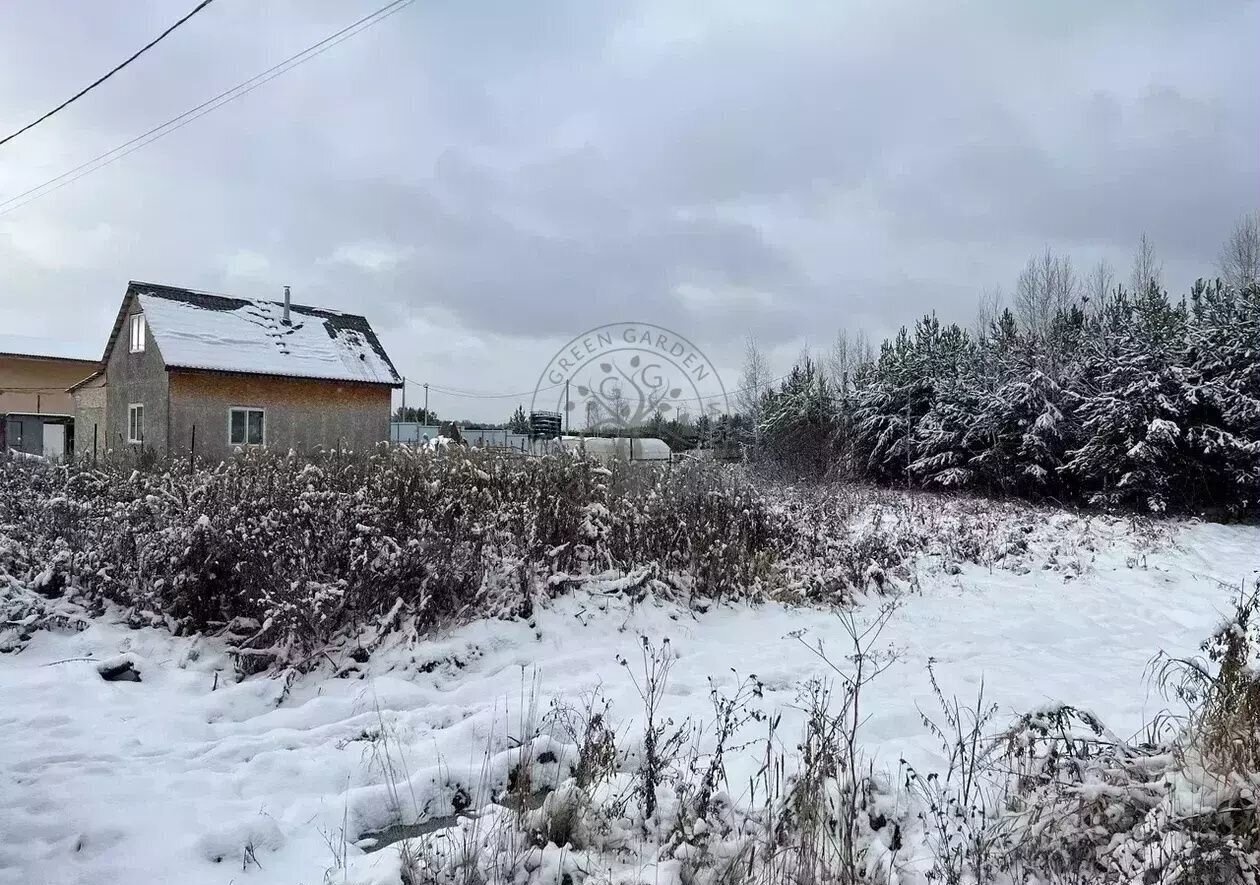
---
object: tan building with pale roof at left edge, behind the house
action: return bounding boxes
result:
[0,335,100,458]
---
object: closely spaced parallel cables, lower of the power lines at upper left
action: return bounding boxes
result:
[0,0,413,217]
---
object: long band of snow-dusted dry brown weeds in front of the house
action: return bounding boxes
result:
[0,448,1131,672]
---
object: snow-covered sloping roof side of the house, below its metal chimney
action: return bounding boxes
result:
[131,282,402,385]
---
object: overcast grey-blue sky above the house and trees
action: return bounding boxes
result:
[0,0,1260,420]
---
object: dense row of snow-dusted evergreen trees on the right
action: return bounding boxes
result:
[741,216,1260,514]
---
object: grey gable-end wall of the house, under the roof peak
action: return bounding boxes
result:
[105,295,170,455]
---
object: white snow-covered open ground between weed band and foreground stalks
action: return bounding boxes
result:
[0,523,1260,885]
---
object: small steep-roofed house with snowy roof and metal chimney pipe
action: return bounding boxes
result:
[72,281,402,459]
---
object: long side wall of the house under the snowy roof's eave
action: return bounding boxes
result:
[167,369,391,460]
